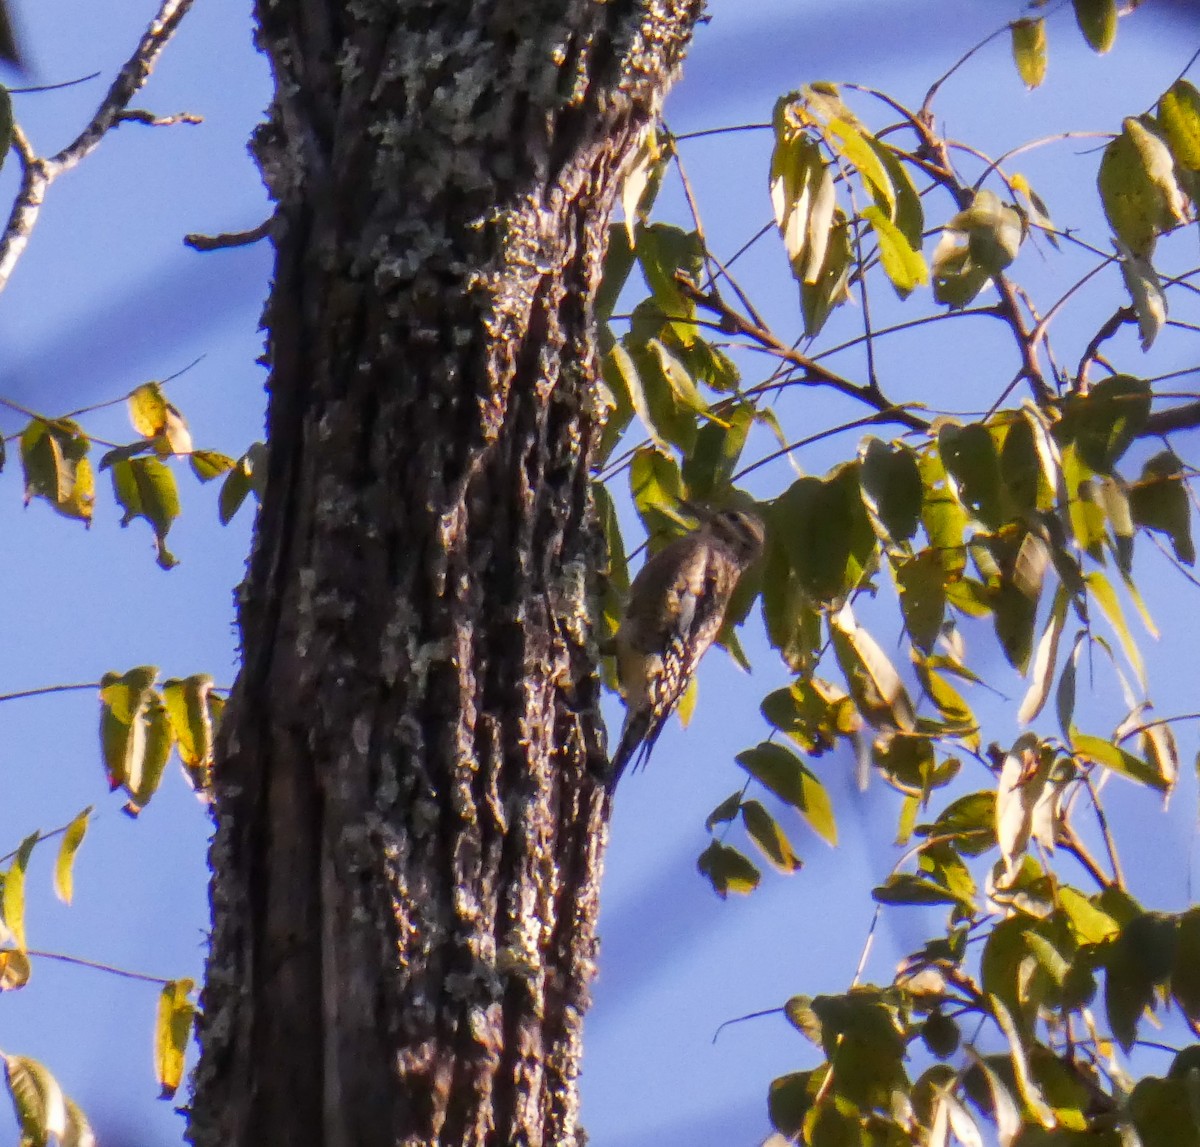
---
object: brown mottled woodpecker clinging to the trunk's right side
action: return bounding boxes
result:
[608,510,763,788]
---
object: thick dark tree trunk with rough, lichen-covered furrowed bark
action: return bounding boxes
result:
[190,0,702,1147]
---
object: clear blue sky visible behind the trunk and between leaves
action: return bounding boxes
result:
[0,0,1198,1147]
